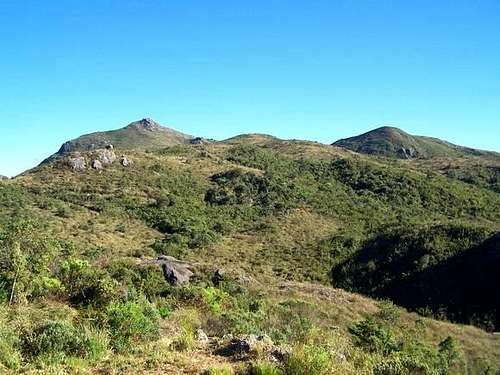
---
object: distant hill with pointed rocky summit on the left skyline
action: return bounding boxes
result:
[49,118,194,159]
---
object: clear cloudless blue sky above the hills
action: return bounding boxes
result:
[0,0,500,175]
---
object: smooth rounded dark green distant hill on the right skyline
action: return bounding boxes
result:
[333,126,495,159]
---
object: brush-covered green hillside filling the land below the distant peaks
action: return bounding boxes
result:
[0,119,500,375]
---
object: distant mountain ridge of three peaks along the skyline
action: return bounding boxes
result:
[42,118,500,167]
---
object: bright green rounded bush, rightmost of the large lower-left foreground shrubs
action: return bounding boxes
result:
[106,299,160,351]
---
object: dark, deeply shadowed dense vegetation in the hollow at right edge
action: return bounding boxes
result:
[332,223,500,331]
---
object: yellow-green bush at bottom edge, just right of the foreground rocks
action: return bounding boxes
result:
[285,345,333,375]
